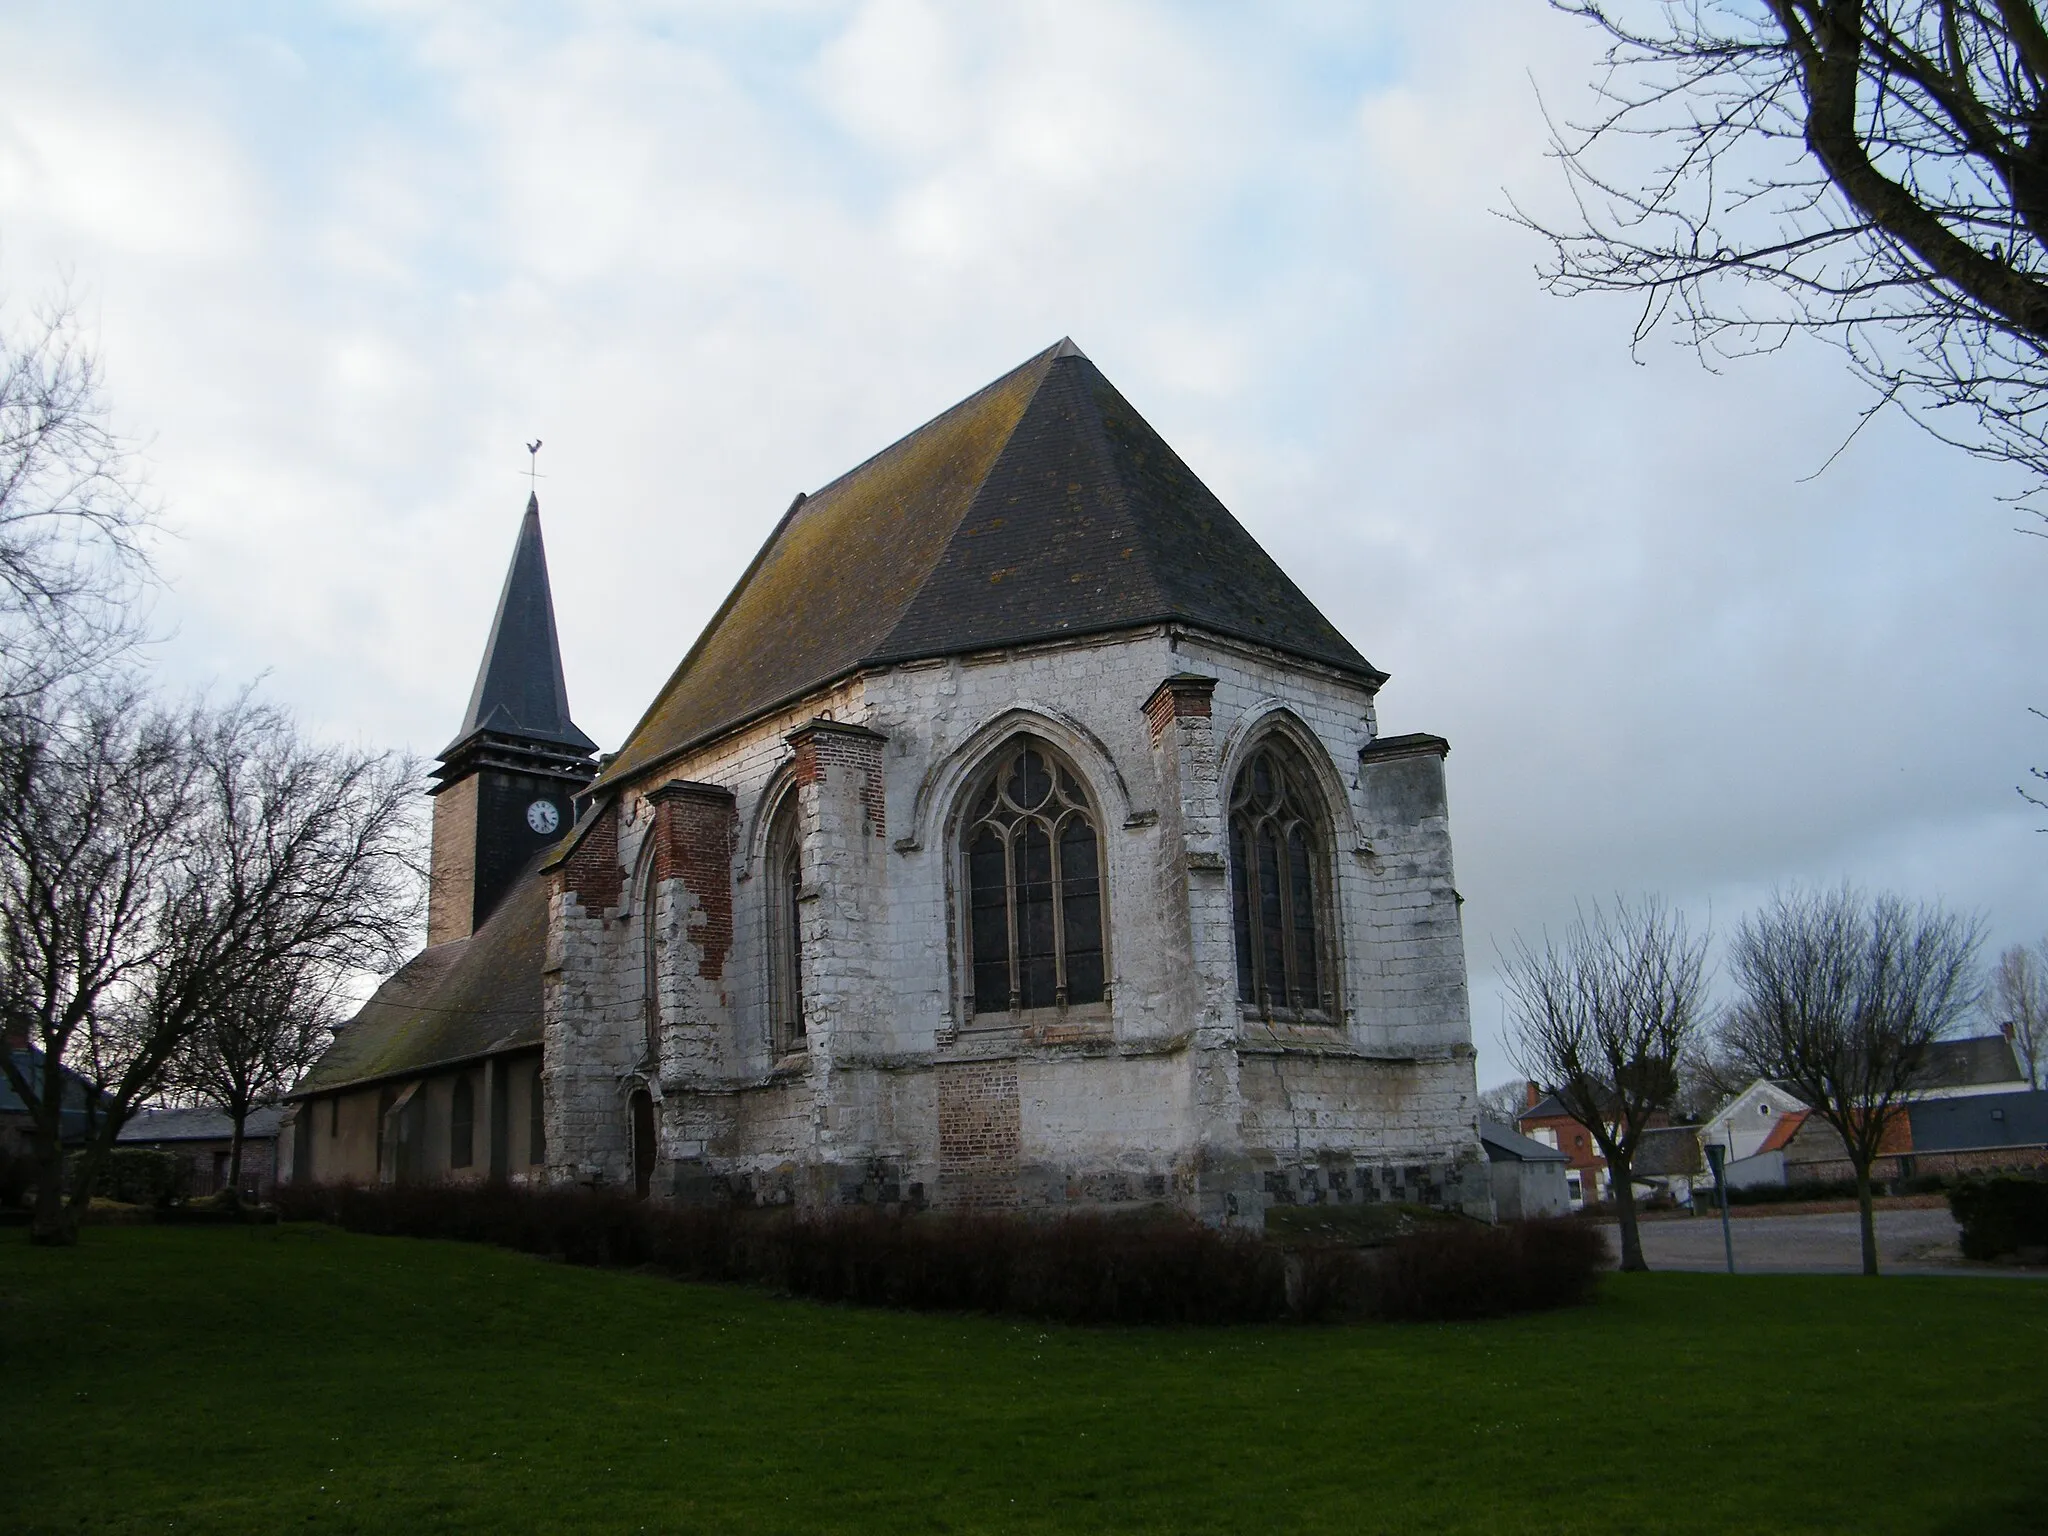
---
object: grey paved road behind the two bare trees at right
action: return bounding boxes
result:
[1608,1208,1962,1274]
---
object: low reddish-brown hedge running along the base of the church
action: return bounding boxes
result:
[279,1186,1608,1323]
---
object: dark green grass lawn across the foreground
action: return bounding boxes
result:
[0,1227,2048,1536]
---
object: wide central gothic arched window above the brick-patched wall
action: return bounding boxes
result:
[961,735,1104,1014]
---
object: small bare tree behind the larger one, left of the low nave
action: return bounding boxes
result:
[164,958,342,1200]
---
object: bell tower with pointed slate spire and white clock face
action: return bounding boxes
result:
[426,496,598,946]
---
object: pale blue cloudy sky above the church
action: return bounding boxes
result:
[0,0,2048,1083]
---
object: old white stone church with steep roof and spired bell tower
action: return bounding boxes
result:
[289,342,1491,1229]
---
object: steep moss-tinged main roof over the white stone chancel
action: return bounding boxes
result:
[598,340,1384,784]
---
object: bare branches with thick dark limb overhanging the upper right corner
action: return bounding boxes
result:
[1516,0,2048,499]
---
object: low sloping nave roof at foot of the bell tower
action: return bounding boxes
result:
[289,858,547,1098]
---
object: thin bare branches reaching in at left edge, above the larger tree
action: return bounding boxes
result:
[0,299,152,698]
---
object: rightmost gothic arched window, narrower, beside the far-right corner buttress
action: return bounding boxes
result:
[1231,741,1331,1016]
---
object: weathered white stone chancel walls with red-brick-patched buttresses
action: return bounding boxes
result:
[543,625,1491,1227]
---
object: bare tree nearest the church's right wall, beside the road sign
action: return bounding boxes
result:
[1505,897,1706,1270]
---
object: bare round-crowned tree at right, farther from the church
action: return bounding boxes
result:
[1722,887,1980,1274]
